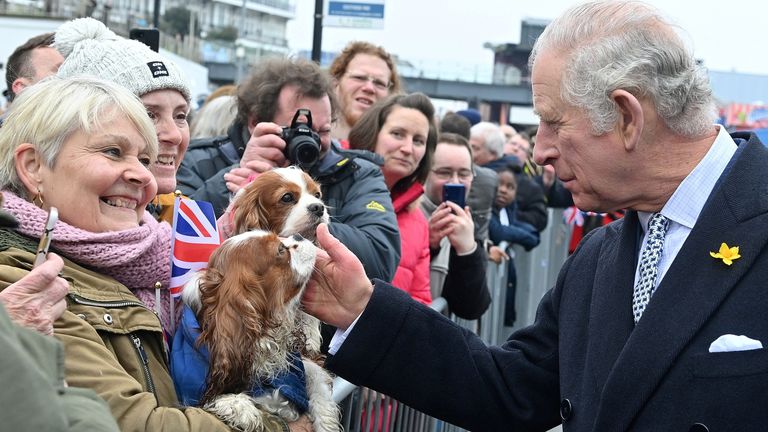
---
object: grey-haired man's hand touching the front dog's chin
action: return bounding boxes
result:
[302,224,373,330]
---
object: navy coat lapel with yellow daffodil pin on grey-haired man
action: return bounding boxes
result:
[595,137,768,430]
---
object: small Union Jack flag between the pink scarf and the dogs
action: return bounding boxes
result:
[171,197,222,298]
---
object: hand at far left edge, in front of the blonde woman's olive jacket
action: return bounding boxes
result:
[0,252,69,335]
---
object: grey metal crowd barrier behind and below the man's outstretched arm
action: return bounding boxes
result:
[333,209,570,432]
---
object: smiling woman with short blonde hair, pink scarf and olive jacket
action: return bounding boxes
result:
[0,75,296,432]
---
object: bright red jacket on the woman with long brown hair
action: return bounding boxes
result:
[392,183,432,305]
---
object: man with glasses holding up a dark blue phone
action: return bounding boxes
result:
[419,133,491,319]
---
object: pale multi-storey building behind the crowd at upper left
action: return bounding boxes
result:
[0,0,296,89]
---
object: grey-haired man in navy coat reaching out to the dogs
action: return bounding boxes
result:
[304,1,768,432]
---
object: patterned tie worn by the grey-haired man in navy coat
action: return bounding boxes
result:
[632,213,669,324]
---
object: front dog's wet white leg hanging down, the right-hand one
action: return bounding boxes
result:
[304,360,342,432]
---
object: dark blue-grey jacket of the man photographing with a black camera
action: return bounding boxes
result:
[176,123,400,281]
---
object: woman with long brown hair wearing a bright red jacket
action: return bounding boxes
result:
[349,93,437,305]
